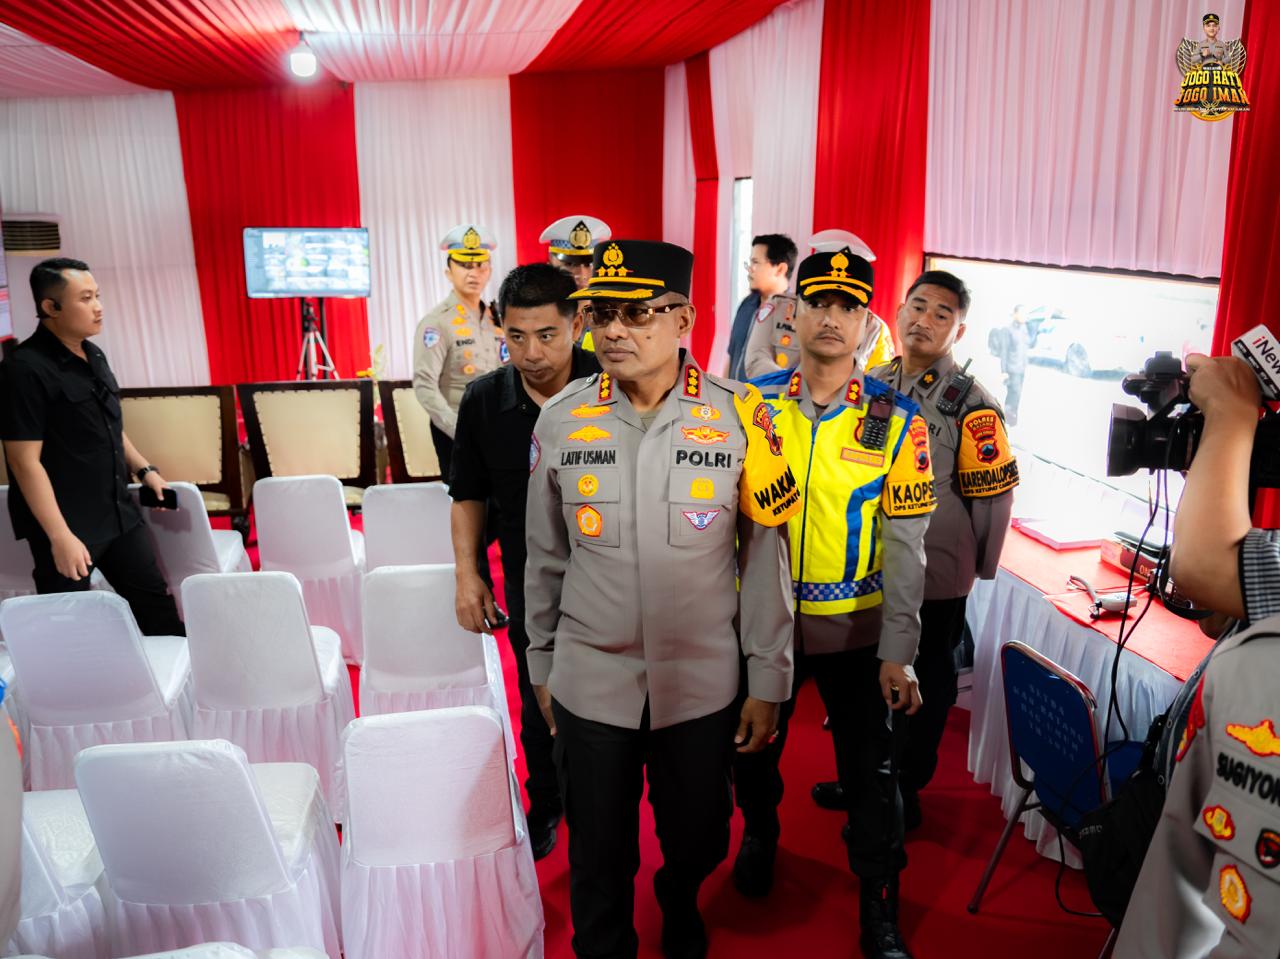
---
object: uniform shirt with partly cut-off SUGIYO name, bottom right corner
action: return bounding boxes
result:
[1115,616,1280,959]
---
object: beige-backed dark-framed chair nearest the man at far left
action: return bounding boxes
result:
[120,387,252,533]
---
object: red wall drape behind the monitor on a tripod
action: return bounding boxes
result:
[175,83,369,384]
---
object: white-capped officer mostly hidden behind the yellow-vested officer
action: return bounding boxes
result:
[746,229,893,378]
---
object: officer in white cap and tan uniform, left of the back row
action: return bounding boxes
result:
[413,223,507,479]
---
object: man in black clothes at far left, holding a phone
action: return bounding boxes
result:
[0,259,186,636]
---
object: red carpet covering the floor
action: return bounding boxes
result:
[235,517,1107,959]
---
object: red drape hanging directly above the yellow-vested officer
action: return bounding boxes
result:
[813,0,929,326]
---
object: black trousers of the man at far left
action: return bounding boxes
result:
[27,522,187,636]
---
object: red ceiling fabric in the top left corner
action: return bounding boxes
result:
[0,0,298,90]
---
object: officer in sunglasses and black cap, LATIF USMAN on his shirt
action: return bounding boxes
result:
[525,239,800,959]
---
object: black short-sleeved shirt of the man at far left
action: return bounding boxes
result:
[0,323,142,545]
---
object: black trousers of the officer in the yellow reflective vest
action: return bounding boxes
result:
[733,647,906,880]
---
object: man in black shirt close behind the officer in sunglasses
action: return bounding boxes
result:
[449,264,600,859]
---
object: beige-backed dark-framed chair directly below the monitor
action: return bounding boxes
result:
[236,379,378,508]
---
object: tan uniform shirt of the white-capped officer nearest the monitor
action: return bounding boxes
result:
[413,292,507,439]
